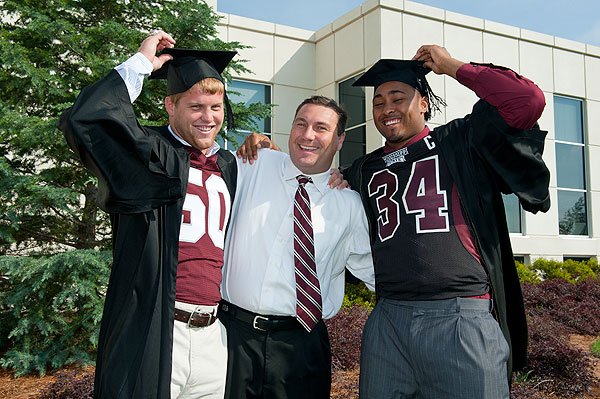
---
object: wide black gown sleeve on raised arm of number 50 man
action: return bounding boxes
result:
[58,70,187,213]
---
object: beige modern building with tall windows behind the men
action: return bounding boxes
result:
[209,0,600,262]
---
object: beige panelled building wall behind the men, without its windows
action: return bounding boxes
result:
[220,0,600,260]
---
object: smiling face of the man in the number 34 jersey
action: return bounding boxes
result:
[373,81,428,148]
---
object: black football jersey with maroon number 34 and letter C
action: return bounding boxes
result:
[363,135,488,300]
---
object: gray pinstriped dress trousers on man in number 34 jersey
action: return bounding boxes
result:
[360,298,509,399]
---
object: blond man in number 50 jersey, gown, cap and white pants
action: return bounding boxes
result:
[59,31,237,399]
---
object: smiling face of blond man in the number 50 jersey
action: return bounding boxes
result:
[165,87,225,153]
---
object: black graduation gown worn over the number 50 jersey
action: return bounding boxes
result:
[59,70,237,398]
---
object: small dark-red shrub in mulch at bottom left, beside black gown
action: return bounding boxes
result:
[40,370,94,399]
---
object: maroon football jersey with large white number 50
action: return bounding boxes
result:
[175,154,231,305]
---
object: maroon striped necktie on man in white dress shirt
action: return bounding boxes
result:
[294,175,322,332]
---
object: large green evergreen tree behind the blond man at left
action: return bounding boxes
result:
[0,0,270,373]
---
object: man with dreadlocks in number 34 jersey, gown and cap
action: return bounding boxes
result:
[344,45,550,399]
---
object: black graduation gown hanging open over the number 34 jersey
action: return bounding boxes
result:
[344,100,550,380]
